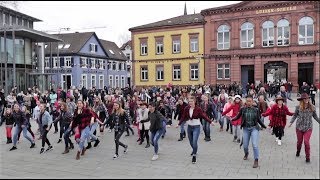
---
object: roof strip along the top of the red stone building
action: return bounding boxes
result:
[201,1,302,15]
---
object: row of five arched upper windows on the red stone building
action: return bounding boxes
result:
[217,16,314,50]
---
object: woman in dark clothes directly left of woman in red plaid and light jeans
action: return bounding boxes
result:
[54,102,74,154]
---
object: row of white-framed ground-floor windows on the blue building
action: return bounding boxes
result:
[80,74,126,89]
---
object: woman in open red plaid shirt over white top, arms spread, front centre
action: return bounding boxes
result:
[176,96,214,164]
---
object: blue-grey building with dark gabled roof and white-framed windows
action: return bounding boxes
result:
[45,32,126,89]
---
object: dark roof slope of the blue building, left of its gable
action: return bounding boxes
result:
[44,32,95,54]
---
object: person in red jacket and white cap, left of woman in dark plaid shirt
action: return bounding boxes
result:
[222,95,243,143]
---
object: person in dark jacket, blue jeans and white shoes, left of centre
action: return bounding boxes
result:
[148,103,166,161]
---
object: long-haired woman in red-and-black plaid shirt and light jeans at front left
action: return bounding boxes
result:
[71,100,94,160]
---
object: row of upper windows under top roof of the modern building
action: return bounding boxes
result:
[0,12,33,29]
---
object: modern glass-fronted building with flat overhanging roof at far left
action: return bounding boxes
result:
[0,6,60,92]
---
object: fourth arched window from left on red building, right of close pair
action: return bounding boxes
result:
[277,19,290,46]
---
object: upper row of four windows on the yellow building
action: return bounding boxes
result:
[140,35,199,56]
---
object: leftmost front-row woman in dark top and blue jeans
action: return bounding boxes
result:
[10,104,36,151]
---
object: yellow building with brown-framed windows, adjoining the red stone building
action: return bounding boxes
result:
[129,14,205,88]
